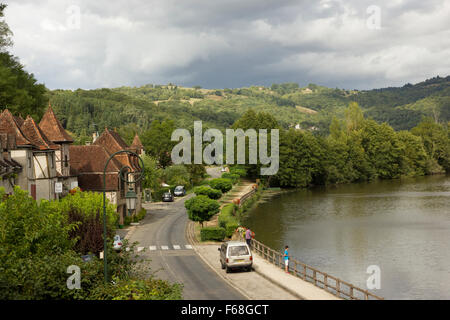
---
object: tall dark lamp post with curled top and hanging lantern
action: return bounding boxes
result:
[103,150,144,284]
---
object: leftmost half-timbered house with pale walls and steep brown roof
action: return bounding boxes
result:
[0,109,58,200]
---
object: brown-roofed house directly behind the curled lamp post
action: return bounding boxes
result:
[69,128,142,224]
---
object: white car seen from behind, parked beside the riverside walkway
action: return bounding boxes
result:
[218,241,253,273]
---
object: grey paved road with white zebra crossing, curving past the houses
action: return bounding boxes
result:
[126,195,245,300]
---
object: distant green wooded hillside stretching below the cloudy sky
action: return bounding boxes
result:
[48,76,450,143]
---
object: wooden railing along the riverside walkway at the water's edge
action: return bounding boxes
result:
[252,239,384,300]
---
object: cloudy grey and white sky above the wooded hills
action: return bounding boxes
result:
[0,0,450,89]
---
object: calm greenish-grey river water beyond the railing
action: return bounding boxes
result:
[244,176,450,299]
